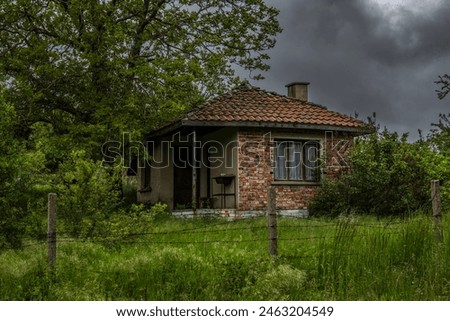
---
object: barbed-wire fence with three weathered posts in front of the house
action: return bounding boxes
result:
[7,180,443,270]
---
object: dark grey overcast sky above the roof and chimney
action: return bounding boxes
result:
[251,0,450,139]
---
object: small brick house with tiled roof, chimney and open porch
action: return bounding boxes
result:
[137,82,367,216]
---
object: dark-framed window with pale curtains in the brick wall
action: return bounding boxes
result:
[274,141,320,182]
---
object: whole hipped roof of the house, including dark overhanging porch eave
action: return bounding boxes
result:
[149,83,370,136]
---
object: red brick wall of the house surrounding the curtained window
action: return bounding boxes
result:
[237,129,352,211]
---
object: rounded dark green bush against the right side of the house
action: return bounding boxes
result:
[310,130,437,216]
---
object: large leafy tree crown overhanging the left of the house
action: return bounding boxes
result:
[0,0,280,150]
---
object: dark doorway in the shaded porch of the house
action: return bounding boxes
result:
[173,146,192,209]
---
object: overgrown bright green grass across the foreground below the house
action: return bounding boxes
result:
[0,215,450,300]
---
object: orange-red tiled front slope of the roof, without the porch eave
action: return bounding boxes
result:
[183,84,366,128]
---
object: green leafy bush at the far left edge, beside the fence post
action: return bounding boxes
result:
[0,97,51,249]
